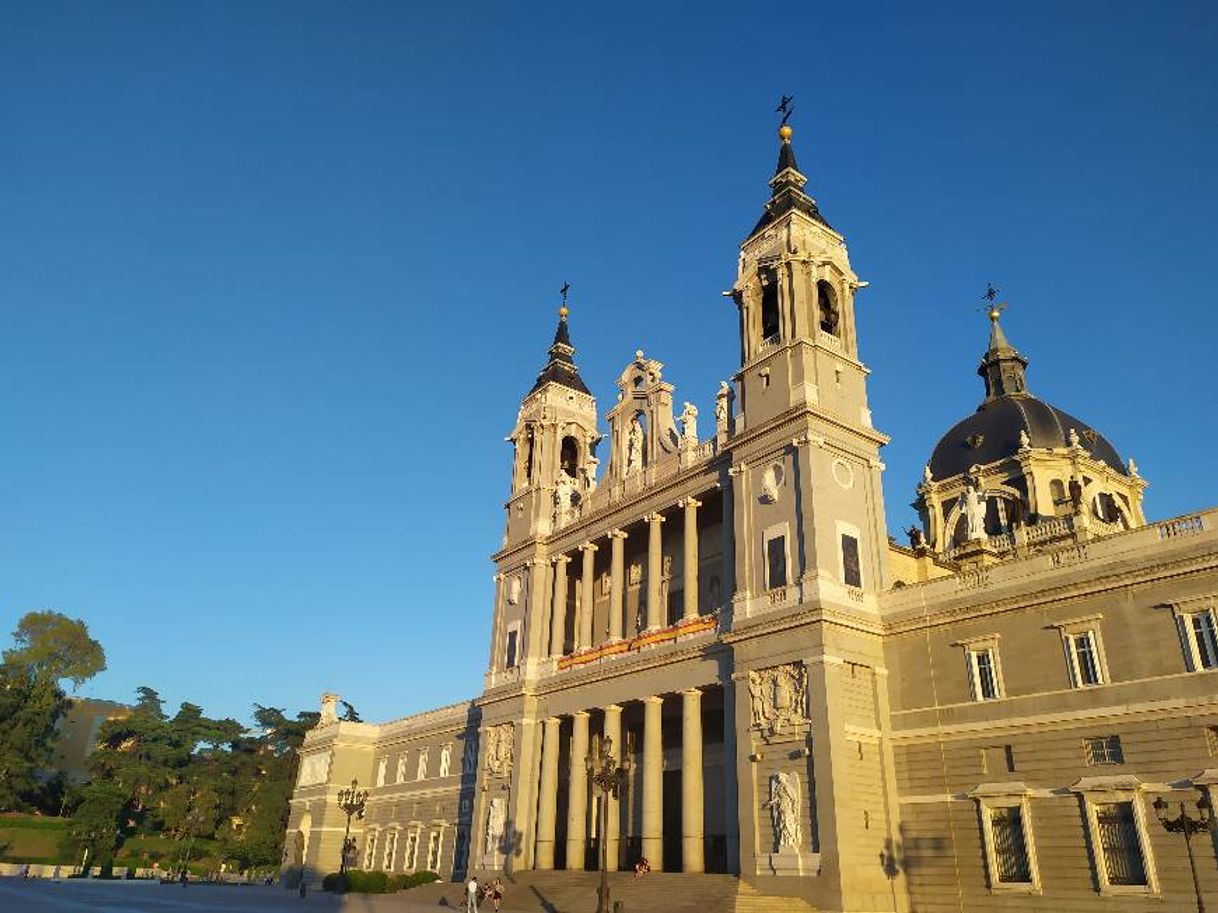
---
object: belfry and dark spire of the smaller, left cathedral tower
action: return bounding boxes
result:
[503,300,600,547]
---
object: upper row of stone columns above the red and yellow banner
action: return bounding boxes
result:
[547,498,702,657]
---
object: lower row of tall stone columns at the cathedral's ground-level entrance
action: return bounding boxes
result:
[535,688,705,872]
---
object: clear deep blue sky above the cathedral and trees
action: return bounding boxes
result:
[0,1,1218,718]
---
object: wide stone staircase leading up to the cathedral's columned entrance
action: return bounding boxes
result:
[400,872,815,913]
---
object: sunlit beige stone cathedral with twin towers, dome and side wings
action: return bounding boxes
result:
[284,125,1218,913]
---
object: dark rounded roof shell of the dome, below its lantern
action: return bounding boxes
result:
[929,393,1125,478]
